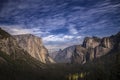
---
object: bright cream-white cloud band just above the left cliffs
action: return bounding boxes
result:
[0,25,45,36]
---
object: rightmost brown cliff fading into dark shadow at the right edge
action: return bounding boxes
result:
[95,33,120,58]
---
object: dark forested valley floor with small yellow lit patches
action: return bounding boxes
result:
[0,52,120,80]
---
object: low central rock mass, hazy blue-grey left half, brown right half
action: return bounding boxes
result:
[55,45,87,63]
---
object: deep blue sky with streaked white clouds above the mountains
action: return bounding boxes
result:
[0,0,120,49]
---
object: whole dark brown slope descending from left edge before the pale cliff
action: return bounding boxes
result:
[0,28,43,68]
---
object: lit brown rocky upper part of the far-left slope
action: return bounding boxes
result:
[0,28,27,59]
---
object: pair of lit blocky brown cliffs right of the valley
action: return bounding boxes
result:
[83,37,113,60]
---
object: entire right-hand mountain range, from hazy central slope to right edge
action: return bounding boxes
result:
[55,32,120,64]
